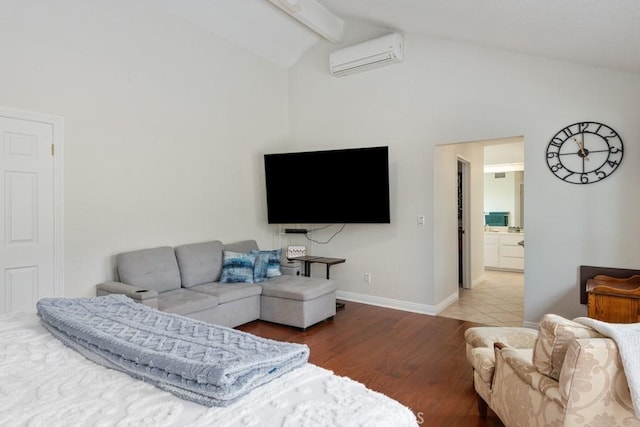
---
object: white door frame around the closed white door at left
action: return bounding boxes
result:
[0,106,64,297]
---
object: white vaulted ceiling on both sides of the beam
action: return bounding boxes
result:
[147,0,640,73]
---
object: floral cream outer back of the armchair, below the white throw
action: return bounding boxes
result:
[559,338,638,425]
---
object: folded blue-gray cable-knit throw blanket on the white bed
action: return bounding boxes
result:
[37,295,309,406]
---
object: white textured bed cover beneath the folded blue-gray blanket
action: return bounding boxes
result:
[0,313,417,427]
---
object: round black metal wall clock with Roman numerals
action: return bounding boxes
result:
[547,122,624,184]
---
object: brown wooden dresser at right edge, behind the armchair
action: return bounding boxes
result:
[587,275,640,323]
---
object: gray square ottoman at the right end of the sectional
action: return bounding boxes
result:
[260,274,336,329]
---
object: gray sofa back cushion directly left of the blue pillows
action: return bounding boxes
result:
[175,240,223,288]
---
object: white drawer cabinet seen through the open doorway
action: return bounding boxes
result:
[484,232,524,271]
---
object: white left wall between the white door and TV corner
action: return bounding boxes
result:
[0,0,288,297]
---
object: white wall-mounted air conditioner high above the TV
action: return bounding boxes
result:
[329,33,404,77]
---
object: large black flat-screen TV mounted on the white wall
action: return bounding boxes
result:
[264,147,391,224]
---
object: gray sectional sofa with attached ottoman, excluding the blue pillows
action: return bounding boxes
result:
[96,240,336,329]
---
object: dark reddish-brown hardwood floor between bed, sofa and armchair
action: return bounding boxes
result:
[238,302,502,427]
